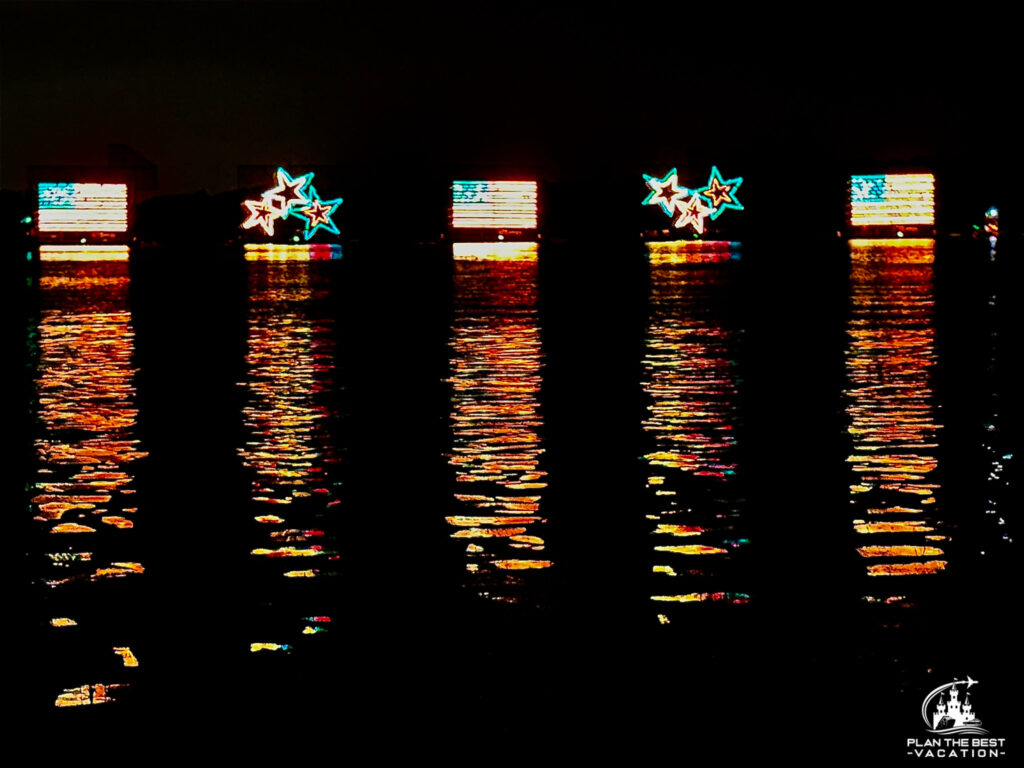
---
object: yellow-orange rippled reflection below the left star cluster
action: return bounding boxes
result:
[239,262,340,650]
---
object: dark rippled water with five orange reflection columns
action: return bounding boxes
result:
[19,241,1020,762]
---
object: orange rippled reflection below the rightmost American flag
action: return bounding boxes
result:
[844,241,946,602]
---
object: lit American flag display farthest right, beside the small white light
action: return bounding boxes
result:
[850,173,935,226]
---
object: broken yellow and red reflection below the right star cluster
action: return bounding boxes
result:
[642,259,750,623]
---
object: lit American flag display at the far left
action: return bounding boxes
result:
[39,182,128,232]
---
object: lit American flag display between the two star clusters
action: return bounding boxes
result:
[452,181,537,229]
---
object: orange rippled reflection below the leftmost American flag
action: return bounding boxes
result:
[30,264,146,606]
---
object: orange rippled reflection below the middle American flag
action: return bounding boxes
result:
[446,260,552,602]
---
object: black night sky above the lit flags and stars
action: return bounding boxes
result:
[0,0,1021,194]
